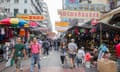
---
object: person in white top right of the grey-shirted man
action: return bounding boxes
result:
[76,47,85,67]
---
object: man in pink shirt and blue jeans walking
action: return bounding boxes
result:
[30,37,41,72]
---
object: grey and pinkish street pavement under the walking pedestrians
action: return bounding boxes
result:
[0,51,97,72]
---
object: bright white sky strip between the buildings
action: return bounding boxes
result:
[44,0,62,30]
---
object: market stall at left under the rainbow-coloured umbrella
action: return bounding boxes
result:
[0,18,29,43]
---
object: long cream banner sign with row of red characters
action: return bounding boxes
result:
[58,10,101,19]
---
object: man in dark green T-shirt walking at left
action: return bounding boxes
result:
[11,37,27,72]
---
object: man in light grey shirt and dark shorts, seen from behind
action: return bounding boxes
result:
[68,39,78,68]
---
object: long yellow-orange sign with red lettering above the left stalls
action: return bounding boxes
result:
[17,14,45,21]
